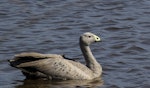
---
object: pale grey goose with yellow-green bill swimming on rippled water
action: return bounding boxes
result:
[9,32,102,80]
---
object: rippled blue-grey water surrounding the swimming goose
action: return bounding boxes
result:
[0,0,150,88]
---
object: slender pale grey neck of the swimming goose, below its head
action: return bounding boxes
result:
[80,42,102,75]
